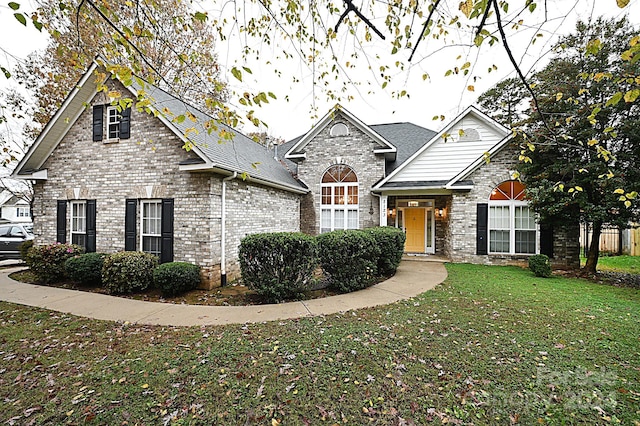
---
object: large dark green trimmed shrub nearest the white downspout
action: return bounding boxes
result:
[239,232,318,302]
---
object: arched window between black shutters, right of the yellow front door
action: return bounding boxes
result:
[489,180,537,254]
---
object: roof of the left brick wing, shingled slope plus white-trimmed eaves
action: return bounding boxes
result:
[13,59,307,192]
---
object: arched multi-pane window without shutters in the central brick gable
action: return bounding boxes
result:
[320,164,358,233]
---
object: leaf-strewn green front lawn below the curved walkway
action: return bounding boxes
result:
[0,265,640,425]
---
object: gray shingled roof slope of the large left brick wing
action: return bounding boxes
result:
[134,80,306,190]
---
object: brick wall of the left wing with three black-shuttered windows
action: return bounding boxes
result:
[34,82,300,287]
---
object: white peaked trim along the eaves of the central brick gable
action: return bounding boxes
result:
[285,104,397,160]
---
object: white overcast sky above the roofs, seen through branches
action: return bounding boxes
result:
[0,0,640,139]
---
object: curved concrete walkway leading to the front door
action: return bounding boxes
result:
[0,260,447,326]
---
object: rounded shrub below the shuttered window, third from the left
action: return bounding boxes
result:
[102,251,158,294]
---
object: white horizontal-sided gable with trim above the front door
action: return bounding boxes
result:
[376,107,511,188]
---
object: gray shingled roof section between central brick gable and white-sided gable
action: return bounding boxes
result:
[370,122,437,175]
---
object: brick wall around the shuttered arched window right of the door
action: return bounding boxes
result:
[446,145,579,268]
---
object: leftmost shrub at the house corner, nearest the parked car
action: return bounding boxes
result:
[25,243,84,283]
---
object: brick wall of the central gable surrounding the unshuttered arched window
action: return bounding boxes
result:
[298,112,384,235]
